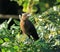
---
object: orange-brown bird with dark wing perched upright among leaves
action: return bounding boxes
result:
[20,13,39,41]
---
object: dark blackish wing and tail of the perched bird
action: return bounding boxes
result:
[26,21,39,40]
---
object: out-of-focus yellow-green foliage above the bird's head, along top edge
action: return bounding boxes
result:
[11,0,60,13]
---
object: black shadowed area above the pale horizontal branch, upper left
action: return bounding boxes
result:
[0,0,22,15]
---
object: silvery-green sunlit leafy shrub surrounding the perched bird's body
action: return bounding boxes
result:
[0,4,60,52]
